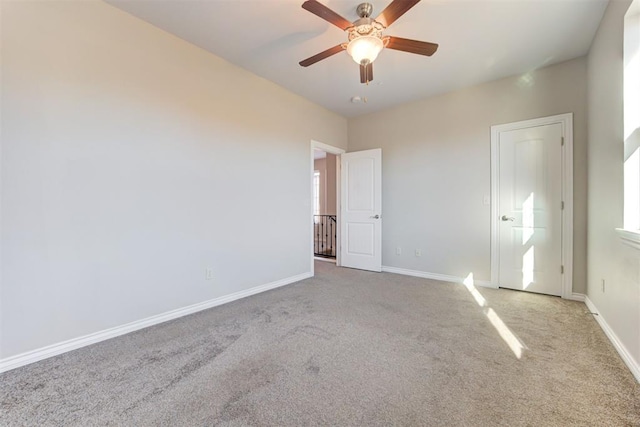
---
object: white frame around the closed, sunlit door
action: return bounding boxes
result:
[491,113,574,299]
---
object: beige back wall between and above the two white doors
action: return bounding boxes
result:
[349,58,587,292]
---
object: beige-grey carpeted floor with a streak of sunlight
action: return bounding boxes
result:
[0,262,640,426]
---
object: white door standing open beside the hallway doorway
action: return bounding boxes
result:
[340,148,382,271]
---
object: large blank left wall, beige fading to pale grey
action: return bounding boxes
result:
[0,0,347,362]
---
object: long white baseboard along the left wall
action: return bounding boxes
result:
[0,272,313,373]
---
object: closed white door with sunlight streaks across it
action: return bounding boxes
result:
[498,123,563,296]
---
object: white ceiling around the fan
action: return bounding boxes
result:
[107,0,607,117]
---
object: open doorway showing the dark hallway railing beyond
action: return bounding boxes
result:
[310,141,344,272]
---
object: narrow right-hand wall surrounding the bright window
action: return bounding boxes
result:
[587,1,640,372]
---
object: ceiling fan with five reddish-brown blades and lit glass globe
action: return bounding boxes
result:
[300,0,438,84]
